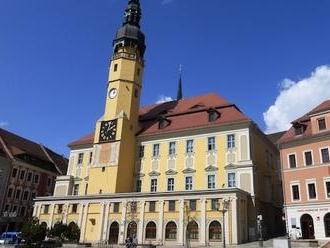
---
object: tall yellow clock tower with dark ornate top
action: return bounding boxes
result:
[86,0,146,194]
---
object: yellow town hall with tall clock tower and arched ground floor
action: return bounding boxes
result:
[34,0,283,247]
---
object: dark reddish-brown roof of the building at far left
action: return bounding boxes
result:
[0,128,68,175]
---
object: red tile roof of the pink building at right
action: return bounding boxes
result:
[278,100,330,144]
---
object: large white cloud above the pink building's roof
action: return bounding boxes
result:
[263,65,330,133]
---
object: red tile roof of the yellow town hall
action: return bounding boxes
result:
[69,94,250,147]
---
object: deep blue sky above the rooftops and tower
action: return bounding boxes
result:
[0,0,330,154]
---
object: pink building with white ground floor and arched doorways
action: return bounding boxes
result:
[278,100,330,239]
